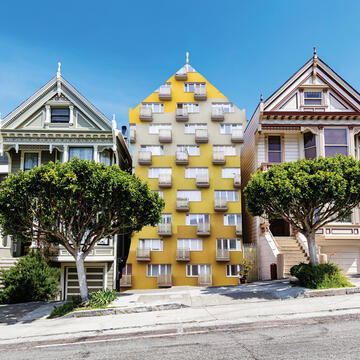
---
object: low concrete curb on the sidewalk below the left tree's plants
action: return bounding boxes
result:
[61,303,189,319]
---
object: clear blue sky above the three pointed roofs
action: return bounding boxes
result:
[0,0,360,125]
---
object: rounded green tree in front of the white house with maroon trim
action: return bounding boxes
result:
[244,155,360,265]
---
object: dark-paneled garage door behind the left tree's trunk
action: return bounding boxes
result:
[65,266,105,300]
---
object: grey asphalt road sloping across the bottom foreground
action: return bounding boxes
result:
[0,318,360,360]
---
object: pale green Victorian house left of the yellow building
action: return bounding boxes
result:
[0,64,131,299]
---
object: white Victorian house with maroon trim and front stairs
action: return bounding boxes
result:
[241,49,360,279]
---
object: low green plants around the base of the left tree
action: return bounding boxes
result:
[48,289,116,319]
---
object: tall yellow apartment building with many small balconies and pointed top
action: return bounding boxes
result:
[121,54,246,289]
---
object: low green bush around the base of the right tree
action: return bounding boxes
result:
[290,263,353,289]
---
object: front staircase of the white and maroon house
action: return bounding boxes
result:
[274,236,309,277]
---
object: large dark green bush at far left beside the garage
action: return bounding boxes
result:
[0,251,60,304]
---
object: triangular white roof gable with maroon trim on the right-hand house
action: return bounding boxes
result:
[263,51,360,113]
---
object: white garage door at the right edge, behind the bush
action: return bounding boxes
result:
[321,246,360,274]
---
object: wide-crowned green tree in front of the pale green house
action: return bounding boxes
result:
[0,159,164,301]
